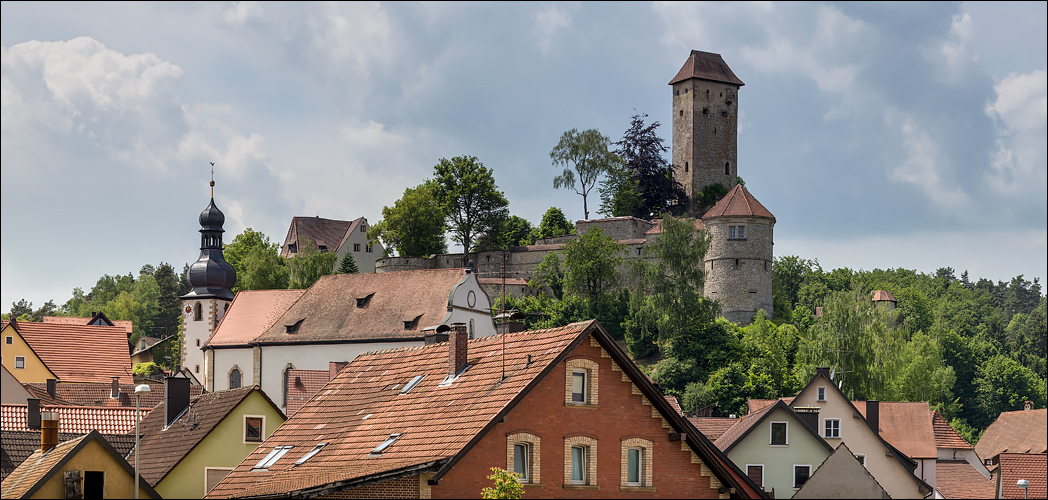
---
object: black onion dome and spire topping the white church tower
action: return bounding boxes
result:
[182,179,237,300]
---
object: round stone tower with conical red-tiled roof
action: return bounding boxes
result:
[702,186,776,325]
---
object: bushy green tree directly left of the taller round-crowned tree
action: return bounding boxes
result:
[368,180,447,257]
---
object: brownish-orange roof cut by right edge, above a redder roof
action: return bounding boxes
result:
[976,408,1048,458]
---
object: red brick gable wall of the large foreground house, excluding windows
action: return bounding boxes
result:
[431,339,721,498]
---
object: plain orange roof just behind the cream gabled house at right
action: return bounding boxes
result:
[852,401,939,459]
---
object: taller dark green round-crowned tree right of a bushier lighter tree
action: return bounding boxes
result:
[433,156,509,254]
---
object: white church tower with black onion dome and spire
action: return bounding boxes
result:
[180,180,237,378]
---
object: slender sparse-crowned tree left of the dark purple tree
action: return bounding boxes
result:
[549,129,618,219]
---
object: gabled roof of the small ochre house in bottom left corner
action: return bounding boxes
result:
[0,431,160,498]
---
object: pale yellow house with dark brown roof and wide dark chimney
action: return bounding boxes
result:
[128,377,285,498]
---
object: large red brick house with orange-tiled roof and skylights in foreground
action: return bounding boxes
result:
[209,321,763,498]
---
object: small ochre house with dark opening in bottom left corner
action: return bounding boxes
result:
[0,431,160,498]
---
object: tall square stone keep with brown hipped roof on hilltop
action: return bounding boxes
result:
[670,50,744,217]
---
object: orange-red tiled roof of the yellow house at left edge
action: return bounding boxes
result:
[3,321,131,383]
